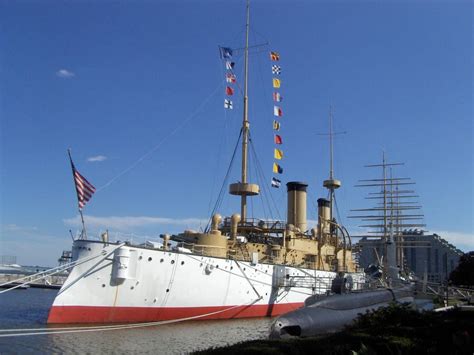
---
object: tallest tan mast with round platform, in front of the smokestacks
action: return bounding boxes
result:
[229,0,259,223]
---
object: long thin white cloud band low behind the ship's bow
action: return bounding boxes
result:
[63,215,207,230]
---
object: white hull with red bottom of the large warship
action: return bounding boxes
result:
[48,240,363,323]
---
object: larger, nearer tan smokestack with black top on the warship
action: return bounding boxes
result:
[286,181,308,232]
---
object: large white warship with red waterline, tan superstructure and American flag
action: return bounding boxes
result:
[48,3,364,323]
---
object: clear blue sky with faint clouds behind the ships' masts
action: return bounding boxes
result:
[0,0,474,266]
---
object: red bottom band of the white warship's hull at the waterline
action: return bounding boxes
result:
[48,303,303,324]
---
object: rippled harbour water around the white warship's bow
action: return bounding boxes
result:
[0,288,272,355]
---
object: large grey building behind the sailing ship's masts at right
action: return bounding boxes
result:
[355,230,463,282]
